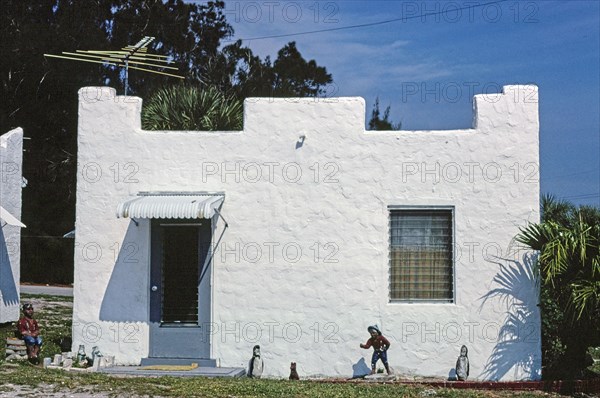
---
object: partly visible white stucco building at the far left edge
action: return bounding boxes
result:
[0,128,23,323]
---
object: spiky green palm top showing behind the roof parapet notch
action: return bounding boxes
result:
[142,85,243,131]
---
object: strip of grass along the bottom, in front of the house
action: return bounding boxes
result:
[0,365,548,398]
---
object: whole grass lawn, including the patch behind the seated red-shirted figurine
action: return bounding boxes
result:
[0,294,584,398]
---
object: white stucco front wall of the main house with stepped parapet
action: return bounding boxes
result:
[73,86,541,380]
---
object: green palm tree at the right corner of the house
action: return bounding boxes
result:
[516,196,600,377]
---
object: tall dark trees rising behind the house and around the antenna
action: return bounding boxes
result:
[0,0,331,282]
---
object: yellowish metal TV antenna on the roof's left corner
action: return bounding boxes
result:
[44,36,184,95]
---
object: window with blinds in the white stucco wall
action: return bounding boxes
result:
[390,209,454,302]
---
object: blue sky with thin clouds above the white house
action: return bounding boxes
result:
[218,0,600,206]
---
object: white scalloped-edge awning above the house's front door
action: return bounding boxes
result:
[117,192,225,219]
